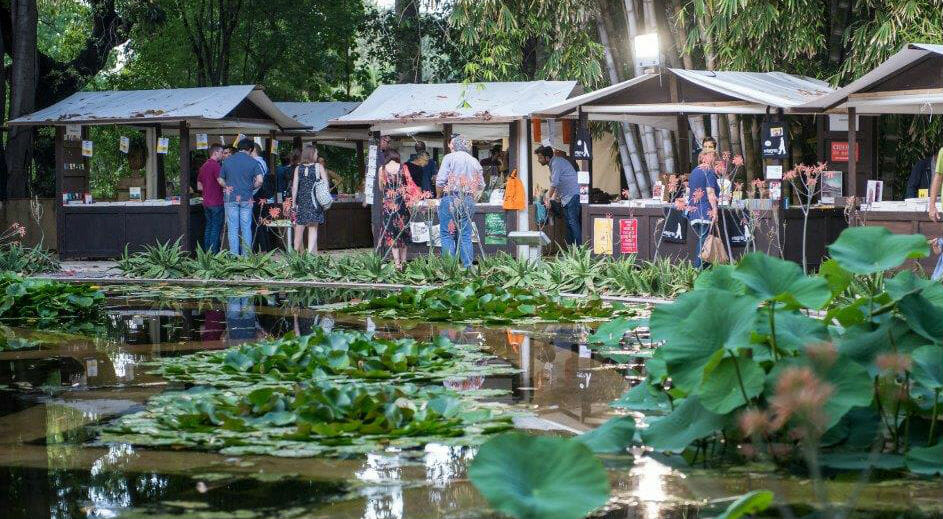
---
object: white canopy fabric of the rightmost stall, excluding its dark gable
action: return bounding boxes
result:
[795,43,943,115]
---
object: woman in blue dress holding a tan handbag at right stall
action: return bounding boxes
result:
[687,151,726,270]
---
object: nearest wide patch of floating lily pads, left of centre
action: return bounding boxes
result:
[100,382,512,457]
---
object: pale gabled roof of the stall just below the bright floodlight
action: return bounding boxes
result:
[533,68,834,129]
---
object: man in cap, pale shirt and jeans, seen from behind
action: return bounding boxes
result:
[435,135,485,268]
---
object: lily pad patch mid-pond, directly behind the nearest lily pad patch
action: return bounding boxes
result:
[156,328,516,387]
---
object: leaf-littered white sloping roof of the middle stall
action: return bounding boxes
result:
[332,81,577,129]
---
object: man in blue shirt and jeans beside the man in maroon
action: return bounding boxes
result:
[219,139,262,256]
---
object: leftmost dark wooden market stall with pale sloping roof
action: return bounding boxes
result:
[8,85,304,259]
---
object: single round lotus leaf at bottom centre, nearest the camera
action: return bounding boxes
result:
[468,433,609,519]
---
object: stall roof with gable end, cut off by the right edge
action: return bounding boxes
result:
[796,43,943,114]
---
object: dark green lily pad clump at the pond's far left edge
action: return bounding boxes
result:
[0,273,105,331]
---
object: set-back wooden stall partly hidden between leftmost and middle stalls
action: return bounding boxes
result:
[275,101,373,250]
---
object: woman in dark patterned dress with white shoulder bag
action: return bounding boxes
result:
[291,144,327,254]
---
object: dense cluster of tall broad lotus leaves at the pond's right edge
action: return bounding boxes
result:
[602,227,943,476]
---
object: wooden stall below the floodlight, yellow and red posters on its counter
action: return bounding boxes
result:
[533,68,847,267]
